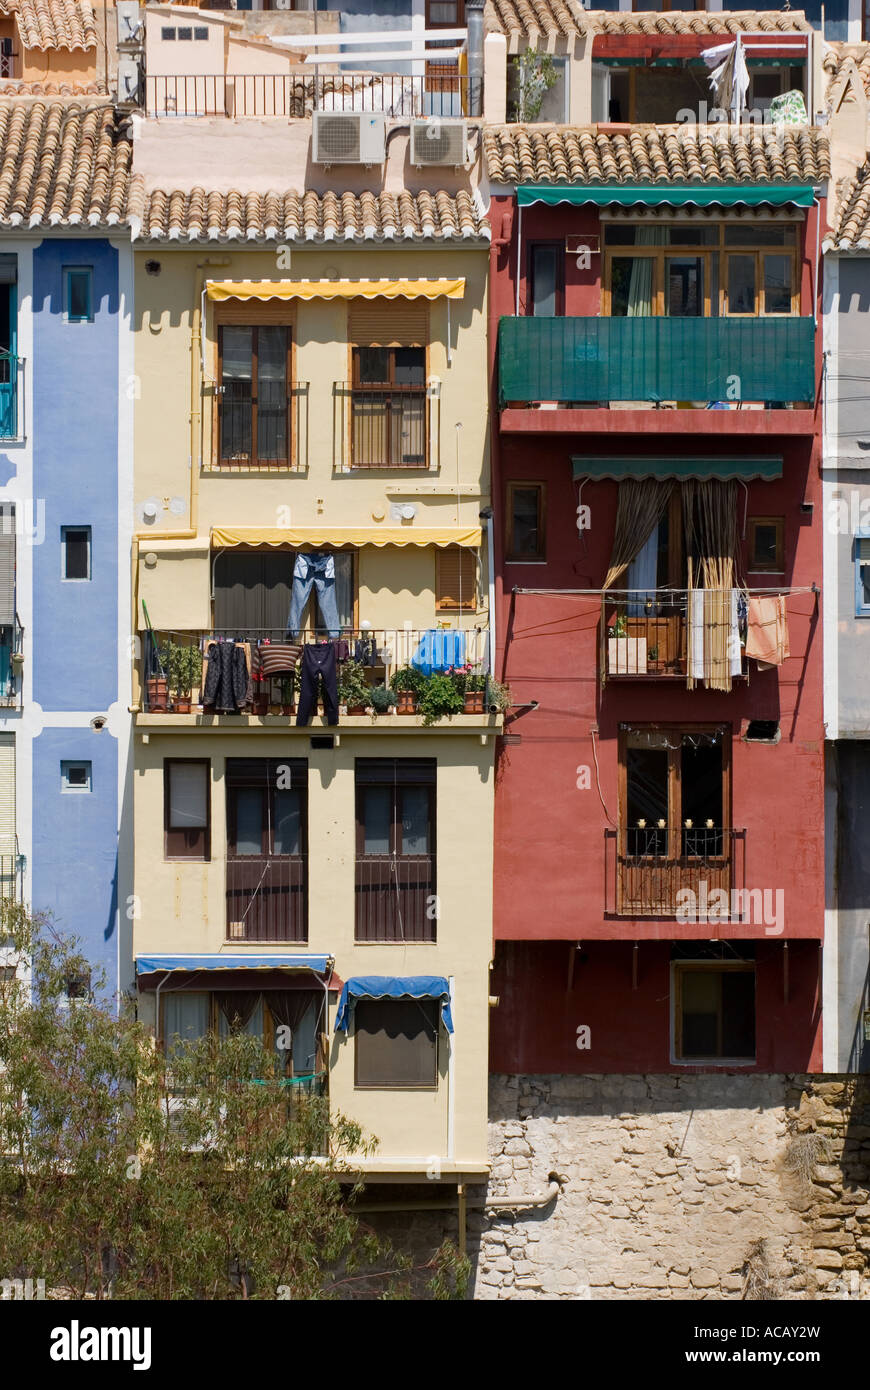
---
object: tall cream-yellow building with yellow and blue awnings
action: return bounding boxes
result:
[131,130,502,1182]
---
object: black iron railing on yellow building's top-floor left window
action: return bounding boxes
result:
[215,381,309,471]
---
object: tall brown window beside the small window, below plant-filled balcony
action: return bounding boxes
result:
[227,758,309,941]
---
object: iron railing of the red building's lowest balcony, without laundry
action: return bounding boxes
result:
[605,826,746,923]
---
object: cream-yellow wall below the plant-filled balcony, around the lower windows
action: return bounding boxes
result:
[133,723,495,1172]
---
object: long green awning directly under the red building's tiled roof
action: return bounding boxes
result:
[517,183,813,207]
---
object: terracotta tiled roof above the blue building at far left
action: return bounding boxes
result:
[0,99,132,228]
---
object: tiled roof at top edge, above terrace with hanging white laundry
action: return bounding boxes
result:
[484,0,812,42]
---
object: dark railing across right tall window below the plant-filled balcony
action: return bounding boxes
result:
[354,855,438,941]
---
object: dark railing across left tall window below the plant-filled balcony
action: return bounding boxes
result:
[227,853,309,941]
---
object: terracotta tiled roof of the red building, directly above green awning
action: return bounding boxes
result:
[484,125,831,183]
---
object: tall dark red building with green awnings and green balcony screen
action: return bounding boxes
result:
[486,125,830,1073]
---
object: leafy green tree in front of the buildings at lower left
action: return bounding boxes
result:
[0,901,468,1300]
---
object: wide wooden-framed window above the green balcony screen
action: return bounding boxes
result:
[603,221,799,318]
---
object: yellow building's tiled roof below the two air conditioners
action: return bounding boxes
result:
[129,181,489,243]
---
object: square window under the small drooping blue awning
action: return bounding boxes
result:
[353,999,441,1090]
